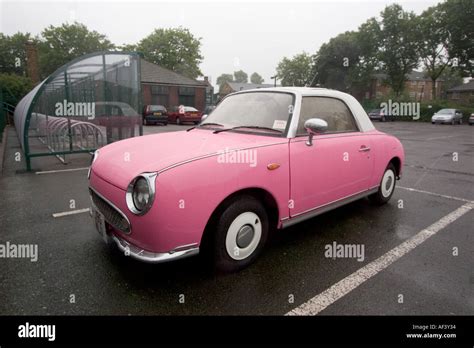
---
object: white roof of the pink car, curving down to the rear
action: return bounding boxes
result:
[233,87,375,132]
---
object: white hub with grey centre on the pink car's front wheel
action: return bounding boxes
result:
[225,212,262,260]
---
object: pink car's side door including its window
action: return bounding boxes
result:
[290,97,373,217]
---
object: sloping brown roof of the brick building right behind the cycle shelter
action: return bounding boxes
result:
[141,59,207,87]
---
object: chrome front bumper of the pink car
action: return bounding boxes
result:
[111,235,199,263]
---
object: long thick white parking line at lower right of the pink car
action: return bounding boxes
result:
[286,202,474,315]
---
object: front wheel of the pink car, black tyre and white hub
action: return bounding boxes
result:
[212,196,268,272]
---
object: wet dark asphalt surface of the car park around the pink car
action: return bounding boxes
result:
[0,122,474,315]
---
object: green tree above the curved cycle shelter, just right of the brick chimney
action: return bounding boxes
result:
[39,22,115,77]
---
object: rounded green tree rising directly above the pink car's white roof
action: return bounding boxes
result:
[276,52,312,86]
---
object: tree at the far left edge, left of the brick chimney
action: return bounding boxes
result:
[0,32,37,75]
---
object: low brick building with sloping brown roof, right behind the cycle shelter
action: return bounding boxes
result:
[141,59,209,111]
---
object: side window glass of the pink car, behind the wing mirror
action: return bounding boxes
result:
[296,97,359,136]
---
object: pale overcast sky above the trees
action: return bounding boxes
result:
[0,0,439,87]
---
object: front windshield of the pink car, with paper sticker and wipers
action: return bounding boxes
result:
[202,92,294,134]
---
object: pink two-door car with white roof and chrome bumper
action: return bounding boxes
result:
[89,87,404,271]
